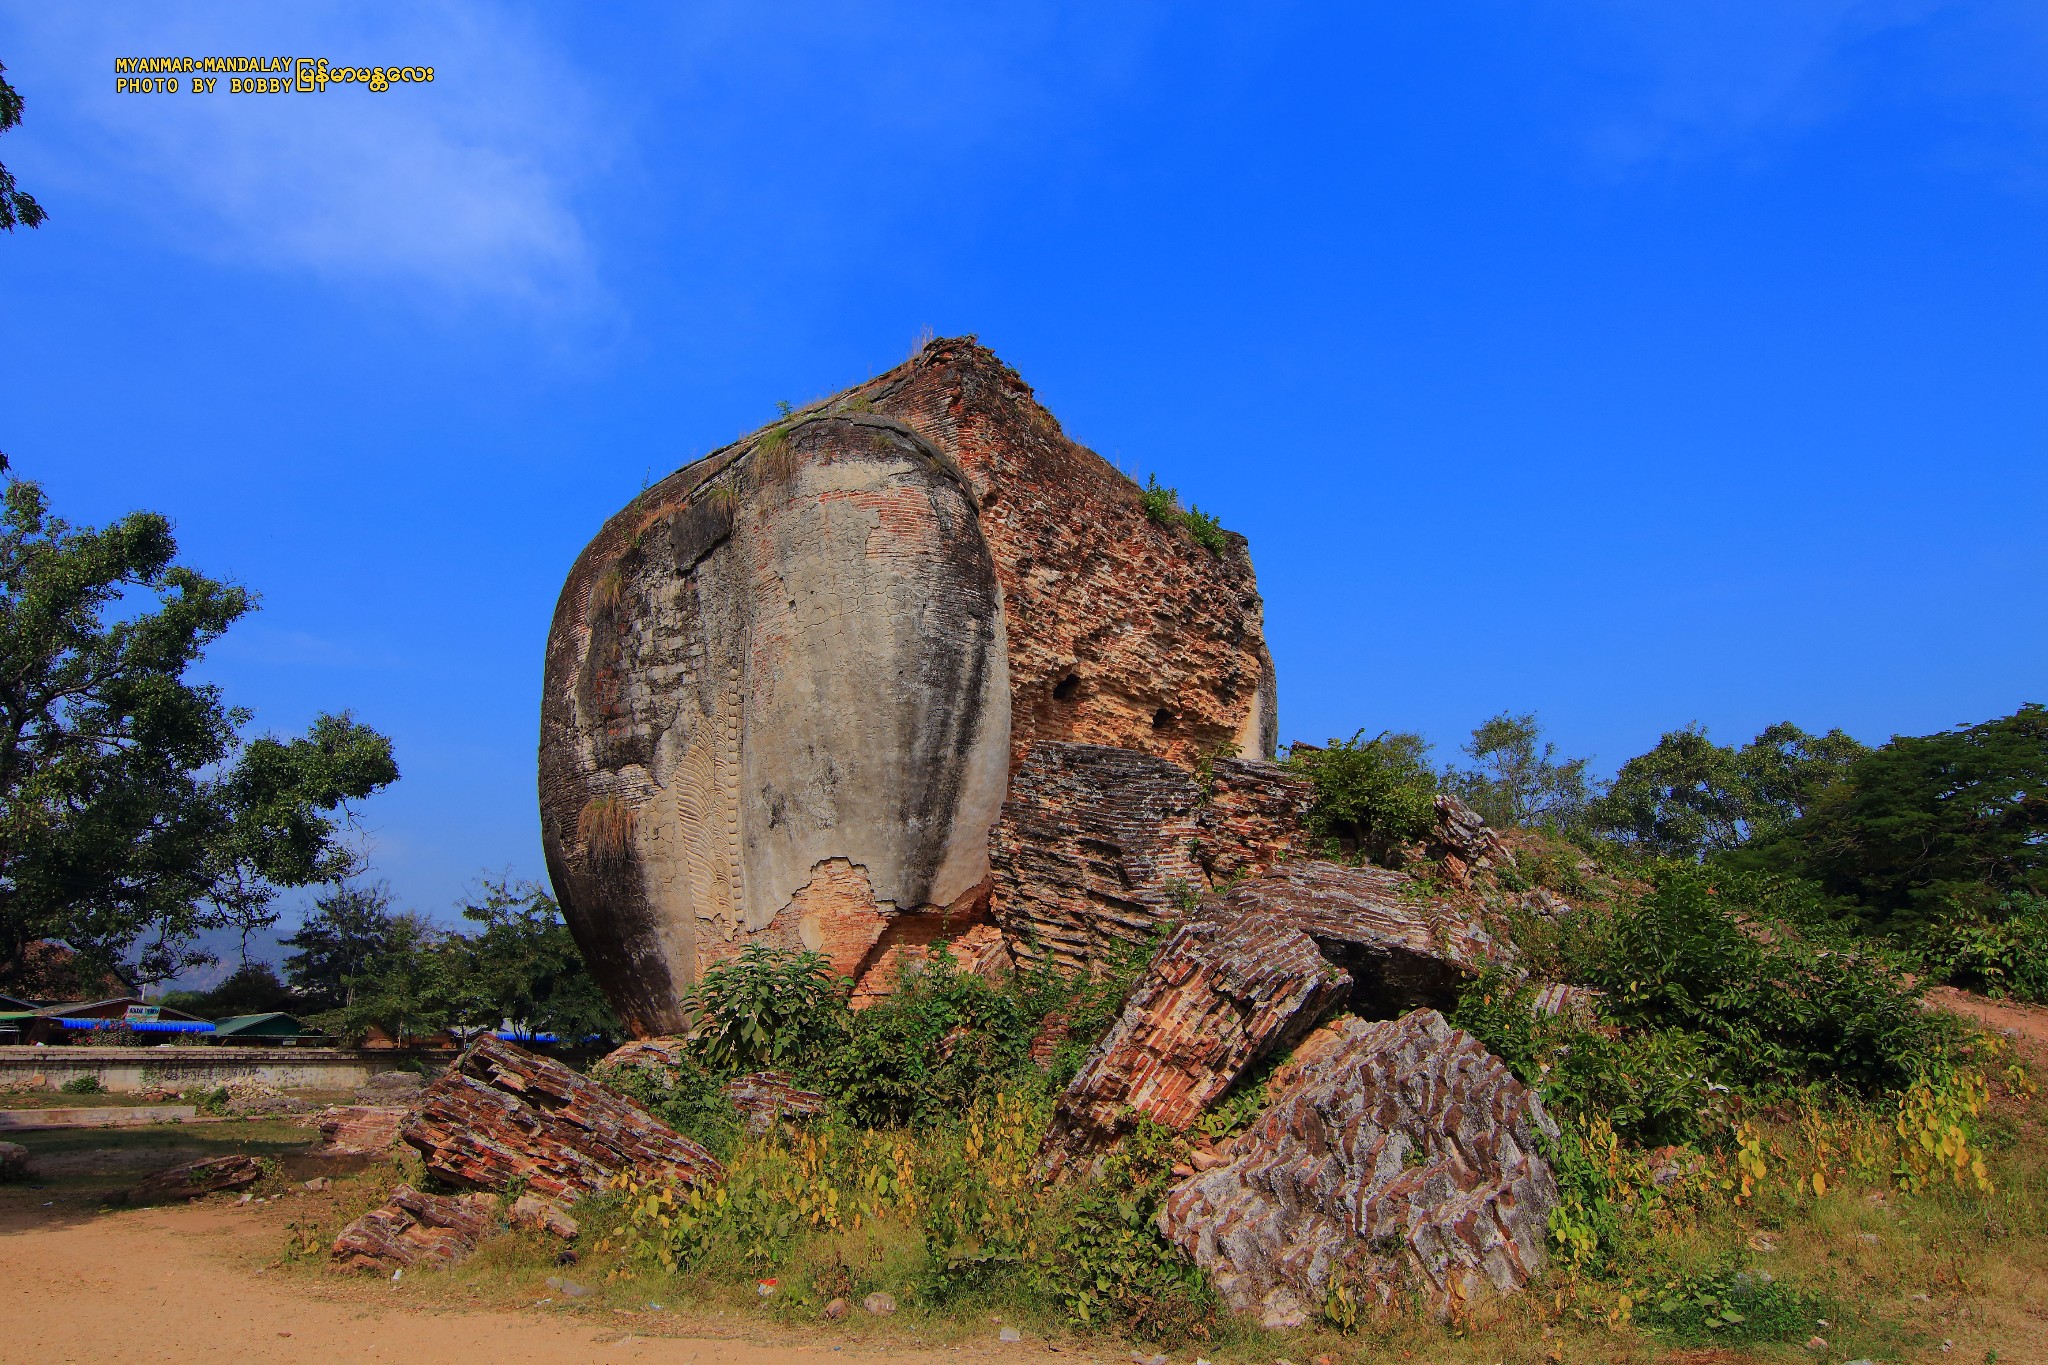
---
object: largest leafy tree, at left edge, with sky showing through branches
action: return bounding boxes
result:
[0,456,397,982]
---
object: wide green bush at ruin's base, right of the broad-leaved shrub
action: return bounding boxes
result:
[815,950,1032,1128]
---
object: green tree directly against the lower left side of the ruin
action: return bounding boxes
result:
[463,878,621,1042]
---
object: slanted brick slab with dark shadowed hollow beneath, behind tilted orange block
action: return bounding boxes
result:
[1223,862,1505,1017]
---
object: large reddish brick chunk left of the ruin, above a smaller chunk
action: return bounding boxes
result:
[399,1036,725,1201]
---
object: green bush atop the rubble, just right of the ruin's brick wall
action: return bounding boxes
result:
[1288,731,1436,862]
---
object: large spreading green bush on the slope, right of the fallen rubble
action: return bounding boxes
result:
[1567,866,1950,1093]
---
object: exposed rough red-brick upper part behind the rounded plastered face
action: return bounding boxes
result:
[856,338,1276,769]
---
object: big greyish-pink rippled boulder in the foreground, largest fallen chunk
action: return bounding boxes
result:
[1159,1009,1559,1316]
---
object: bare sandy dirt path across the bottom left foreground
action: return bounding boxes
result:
[0,1205,1040,1365]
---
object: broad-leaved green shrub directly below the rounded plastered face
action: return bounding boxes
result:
[684,943,848,1072]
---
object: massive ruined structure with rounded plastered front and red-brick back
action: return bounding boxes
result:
[541,340,1276,1036]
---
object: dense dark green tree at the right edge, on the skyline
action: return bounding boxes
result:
[1755,704,2048,929]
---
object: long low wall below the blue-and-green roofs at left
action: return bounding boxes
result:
[0,1046,457,1093]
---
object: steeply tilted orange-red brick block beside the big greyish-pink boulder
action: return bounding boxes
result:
[1040,915,1350,1175]
